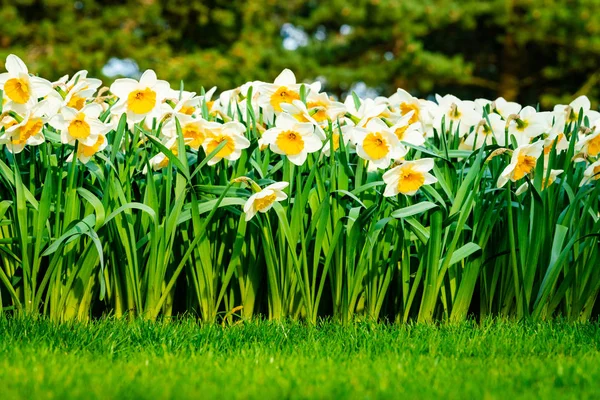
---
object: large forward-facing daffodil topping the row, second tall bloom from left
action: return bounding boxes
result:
[110,69,169,124]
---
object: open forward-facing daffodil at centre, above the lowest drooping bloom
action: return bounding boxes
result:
[261,113,323,165]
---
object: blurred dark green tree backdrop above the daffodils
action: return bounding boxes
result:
[0,0,600,106]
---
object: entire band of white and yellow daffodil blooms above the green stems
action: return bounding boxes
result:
[0,55,600,222]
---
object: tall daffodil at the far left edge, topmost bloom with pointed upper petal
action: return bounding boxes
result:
[0,54,53,108]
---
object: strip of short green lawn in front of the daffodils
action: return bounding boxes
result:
[0,318,600,400]
